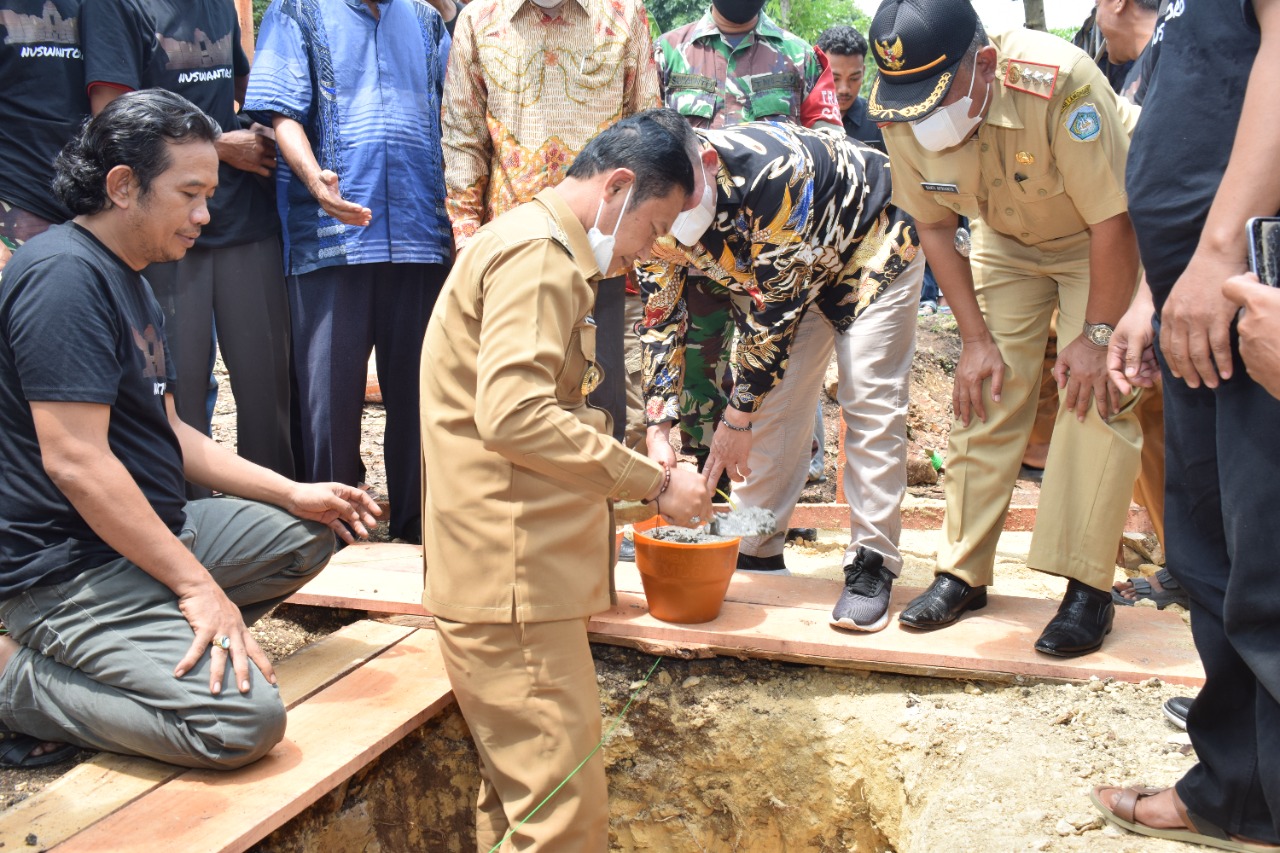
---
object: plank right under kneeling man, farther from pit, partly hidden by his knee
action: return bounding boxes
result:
[0,621,413,849]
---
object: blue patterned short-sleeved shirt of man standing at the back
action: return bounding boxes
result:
[244,0,453,275]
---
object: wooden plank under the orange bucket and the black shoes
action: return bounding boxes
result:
[590,566,1204,686]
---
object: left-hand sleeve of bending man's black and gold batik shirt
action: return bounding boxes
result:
[635,252,689,424]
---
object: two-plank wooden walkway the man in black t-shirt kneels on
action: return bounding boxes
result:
[0,621,452,853]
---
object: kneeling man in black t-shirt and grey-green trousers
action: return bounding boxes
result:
[0,90,378,767]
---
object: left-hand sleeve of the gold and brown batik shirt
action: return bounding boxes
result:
[440,9,493,250]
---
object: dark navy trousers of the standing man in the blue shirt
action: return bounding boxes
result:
[289,258,449,542]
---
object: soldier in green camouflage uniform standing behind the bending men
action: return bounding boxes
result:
[657,0,841,467]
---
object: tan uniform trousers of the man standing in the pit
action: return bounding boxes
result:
[436,619,609,853]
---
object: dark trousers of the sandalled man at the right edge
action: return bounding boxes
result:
[1161,327,1280,844]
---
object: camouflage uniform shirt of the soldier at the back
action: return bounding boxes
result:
[657,10,841,128]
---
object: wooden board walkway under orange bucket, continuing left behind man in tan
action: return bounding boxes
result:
[291,544,1204,686]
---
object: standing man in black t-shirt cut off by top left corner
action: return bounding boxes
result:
[0,0,88,269]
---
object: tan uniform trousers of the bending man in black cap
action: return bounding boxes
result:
[937,222,1142,589]
